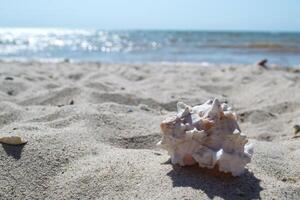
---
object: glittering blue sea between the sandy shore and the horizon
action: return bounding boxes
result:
[0,28,300,65]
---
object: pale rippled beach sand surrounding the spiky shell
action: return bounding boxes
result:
[0,62,300,200]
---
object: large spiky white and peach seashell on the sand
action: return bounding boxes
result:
[157,99,253,176]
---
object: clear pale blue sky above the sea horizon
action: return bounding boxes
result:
[0,0,300,32]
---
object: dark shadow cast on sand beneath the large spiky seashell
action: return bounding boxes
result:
[167,165,262,200]
